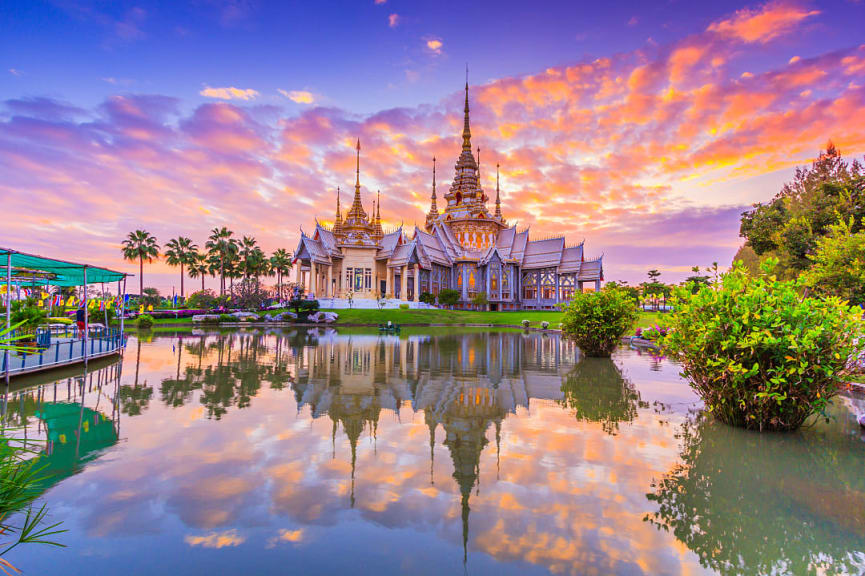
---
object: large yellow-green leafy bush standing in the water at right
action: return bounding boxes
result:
[661,259,863,430]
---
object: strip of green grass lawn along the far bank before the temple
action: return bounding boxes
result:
[128,309,665,328]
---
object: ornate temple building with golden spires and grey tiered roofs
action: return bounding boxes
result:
[295,83,604,310]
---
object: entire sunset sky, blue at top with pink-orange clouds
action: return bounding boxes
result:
[0,0,865,293]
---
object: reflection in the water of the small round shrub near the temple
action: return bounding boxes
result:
[560,358,648,434]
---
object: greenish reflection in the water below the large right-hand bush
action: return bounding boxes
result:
[647,416,865,575]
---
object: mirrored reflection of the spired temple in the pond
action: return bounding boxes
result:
[293,332,579,559]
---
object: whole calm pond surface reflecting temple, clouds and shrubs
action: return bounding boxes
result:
[6,329,865,575]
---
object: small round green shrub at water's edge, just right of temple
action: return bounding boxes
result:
[562,287,637,358]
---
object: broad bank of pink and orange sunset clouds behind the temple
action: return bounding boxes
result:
[0,4,865,287]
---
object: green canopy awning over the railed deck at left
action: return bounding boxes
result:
[0,248,127,286]
